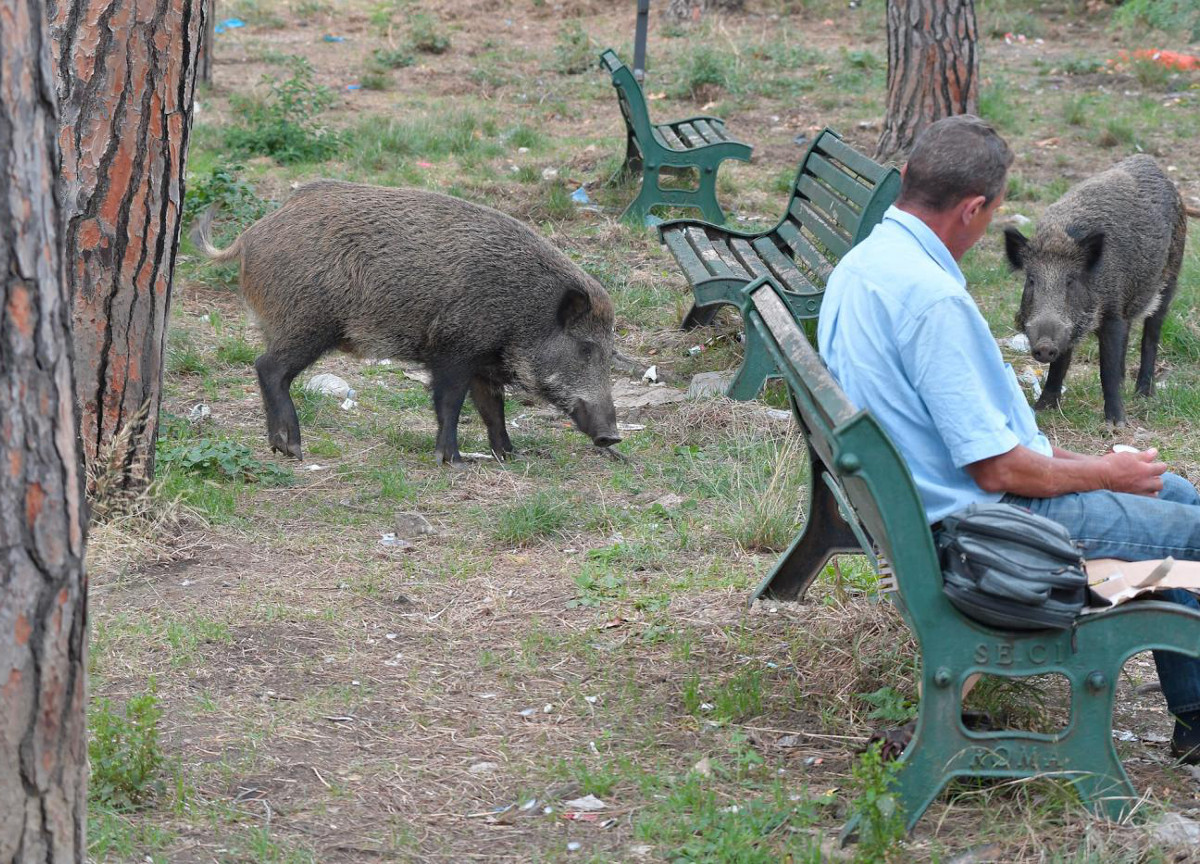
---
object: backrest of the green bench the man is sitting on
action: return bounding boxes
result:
[745,277,956,634]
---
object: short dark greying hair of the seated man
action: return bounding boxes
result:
[896,114,1013,212]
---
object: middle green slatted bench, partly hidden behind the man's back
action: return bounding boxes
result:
[659,128,900,400]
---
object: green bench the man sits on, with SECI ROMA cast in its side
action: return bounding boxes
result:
[745,277,1200,830]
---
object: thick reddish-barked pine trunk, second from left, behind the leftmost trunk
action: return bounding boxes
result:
[50,0,206,492]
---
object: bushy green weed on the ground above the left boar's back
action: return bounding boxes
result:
[226,56,341,164]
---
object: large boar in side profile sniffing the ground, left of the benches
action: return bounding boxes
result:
[196,180,620,464]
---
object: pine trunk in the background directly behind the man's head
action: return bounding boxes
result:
[875,0,979,162]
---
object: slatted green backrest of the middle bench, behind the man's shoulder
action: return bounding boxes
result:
[774,127,900,292]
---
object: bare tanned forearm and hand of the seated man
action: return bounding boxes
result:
[966,445,1166,498]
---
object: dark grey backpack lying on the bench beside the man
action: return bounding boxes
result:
[937,503,1088,630]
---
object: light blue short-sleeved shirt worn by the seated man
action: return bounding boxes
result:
[817,206,1054,523]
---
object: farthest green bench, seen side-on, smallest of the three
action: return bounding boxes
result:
[600,48,754,224]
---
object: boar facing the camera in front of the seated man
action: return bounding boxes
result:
[1004,156,1187,426]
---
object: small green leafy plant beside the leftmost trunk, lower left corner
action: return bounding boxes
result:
[88,682,166,810]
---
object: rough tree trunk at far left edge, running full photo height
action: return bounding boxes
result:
[0,0,88,864]
